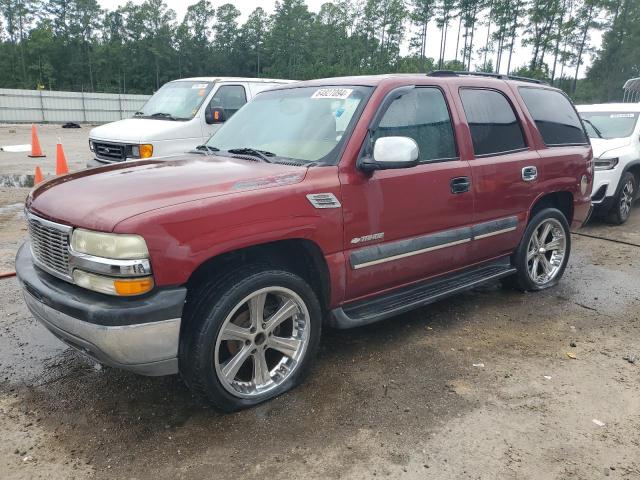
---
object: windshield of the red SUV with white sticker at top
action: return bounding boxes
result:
[207,86,371,163]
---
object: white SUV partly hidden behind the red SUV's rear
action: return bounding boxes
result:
[576,103,640,224]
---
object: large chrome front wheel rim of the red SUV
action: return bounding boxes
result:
[213,287,310,398]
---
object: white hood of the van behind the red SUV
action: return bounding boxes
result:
[89,118,200,143]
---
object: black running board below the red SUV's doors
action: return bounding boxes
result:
[329,257,516,329]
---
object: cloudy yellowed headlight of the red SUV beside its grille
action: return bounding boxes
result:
[71,228,149,260]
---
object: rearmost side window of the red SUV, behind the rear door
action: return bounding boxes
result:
[518,87,587,147]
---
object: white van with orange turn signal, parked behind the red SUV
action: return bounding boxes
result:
[87,77,291,167]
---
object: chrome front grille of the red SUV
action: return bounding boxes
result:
[27,214,71,279]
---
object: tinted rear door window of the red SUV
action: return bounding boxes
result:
[460,88,526,155]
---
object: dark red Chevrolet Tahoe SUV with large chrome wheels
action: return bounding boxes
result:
[16,72,593,411]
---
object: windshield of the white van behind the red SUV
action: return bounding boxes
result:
[134,80,213,120]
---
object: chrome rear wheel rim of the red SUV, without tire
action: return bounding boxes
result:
[527,218,567,285]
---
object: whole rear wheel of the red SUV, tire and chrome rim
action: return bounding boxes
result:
[503,208,571,292]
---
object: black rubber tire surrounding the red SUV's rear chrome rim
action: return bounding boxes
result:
[513,208,571,291]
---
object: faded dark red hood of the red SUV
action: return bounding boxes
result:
[27,154,307,231]
